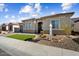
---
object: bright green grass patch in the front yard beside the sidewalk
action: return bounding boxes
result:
[7,34,35,41]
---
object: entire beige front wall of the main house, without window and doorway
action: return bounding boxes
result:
[23,15,71,34]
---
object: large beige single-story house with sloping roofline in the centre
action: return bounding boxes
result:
[22,12,74,34]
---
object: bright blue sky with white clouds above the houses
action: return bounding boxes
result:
[0,3,79,24]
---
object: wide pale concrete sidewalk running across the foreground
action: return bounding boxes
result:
[0,36,79,56]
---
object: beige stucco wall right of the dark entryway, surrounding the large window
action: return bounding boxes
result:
[43,15,72,34]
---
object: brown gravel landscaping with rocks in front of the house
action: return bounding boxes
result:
[37,35,79,52]
